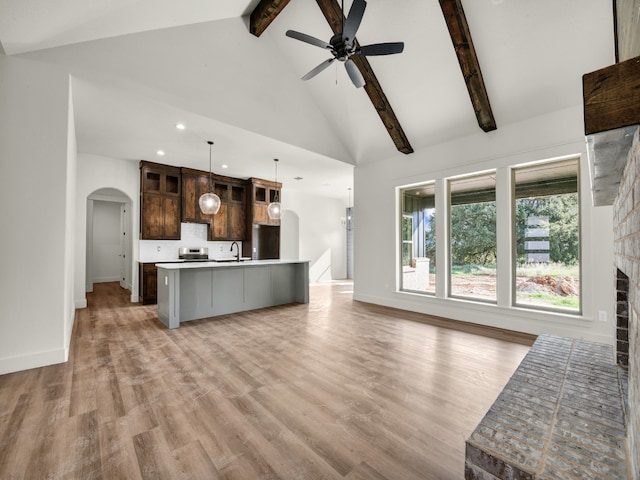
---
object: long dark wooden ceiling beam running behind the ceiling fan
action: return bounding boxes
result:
[316,0,413,154]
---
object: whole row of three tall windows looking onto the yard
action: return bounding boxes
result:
[398,158,581,314]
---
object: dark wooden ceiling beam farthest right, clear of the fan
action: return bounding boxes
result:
[440,0,497,132]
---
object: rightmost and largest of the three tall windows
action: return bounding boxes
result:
[513,159,580,311]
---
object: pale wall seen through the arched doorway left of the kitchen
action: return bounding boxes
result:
[91,200,121,283]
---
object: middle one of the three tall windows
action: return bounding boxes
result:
[449,172,497,302]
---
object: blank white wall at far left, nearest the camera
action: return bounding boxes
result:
[0,56,74,374]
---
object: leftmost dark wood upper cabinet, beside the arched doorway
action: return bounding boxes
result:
[140,161,182,240]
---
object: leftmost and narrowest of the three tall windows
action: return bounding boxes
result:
[401,182,436,294]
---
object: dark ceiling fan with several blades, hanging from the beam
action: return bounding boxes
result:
[286,0,404,88]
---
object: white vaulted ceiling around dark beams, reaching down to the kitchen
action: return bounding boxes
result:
[0,0,614,198]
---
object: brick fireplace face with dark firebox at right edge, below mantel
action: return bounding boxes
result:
[613,128,640,479]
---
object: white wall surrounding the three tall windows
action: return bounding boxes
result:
[354,107,614,343]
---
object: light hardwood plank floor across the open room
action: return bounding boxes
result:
[0,283,533,480]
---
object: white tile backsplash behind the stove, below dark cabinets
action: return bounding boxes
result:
[138,223,242,262]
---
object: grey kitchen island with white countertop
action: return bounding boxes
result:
[156,260,309,328]
